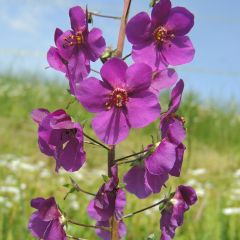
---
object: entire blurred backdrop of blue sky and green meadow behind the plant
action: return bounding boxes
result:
[0,0,240,240]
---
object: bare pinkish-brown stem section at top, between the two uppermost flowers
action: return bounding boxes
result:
[115,0,132,57]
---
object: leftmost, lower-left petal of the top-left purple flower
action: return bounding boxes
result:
[47,47,67,73]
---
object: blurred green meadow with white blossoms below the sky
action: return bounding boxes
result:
[0,76,240,240]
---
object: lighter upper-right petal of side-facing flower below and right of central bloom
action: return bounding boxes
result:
[145,139,176,175]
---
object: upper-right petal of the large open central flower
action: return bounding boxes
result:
[126,63,152,93]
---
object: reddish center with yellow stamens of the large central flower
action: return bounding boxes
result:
[105,88,128,110]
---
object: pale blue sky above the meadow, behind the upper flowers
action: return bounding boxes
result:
[0,0,240,101]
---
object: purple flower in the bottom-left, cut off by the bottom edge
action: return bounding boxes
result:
[28,197,67,240]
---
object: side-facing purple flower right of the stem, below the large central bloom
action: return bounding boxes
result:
[123,139,176,198]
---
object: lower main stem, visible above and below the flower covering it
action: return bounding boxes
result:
[108,145,119,240]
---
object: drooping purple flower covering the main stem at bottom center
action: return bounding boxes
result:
[88,166,126,222]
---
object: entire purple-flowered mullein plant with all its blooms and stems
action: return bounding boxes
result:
[28,0,197,240]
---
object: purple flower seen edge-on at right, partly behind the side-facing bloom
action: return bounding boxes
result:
[160,80,186,177]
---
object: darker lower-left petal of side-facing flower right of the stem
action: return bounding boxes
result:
[123,165,152,199]
